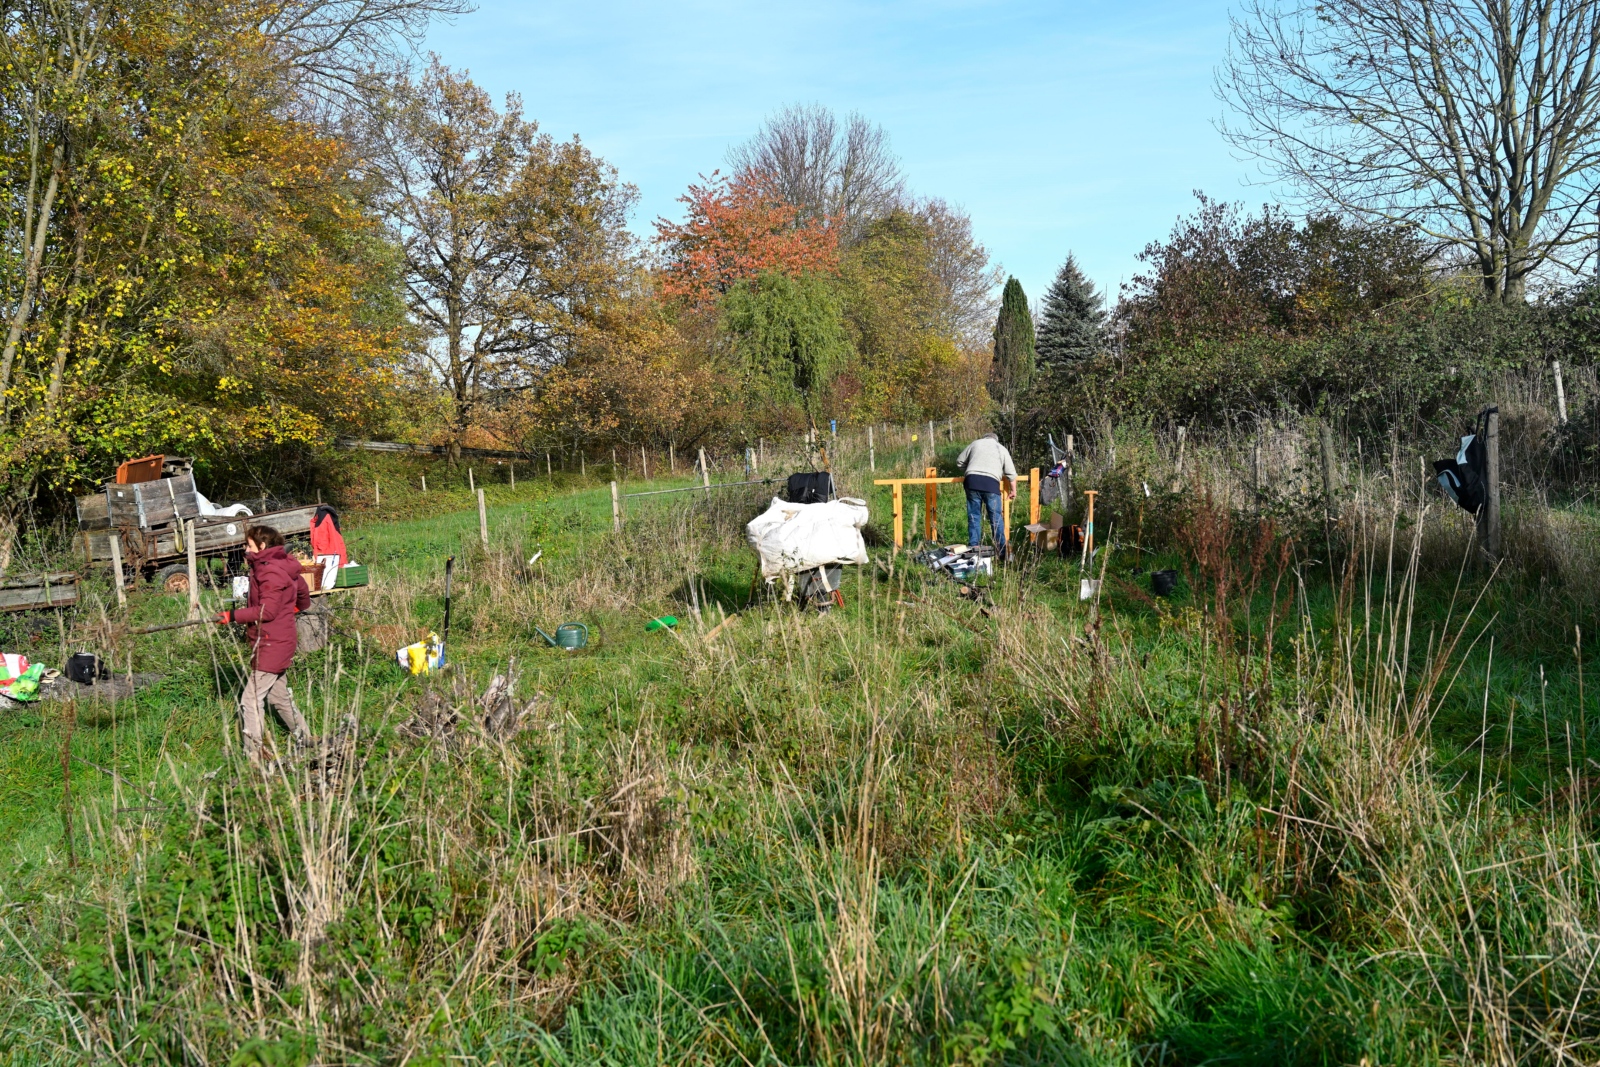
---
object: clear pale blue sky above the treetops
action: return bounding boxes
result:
[427,0,1274,308]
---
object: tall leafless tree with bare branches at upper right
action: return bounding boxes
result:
[1218,0,1600,302]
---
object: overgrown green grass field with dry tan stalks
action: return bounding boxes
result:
[0,438,1600,1065]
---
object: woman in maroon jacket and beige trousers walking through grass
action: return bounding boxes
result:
[216,526,310,761]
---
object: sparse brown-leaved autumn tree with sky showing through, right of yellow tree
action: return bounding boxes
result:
[365,58,635,456]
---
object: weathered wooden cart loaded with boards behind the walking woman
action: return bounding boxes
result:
[78,470,317,593]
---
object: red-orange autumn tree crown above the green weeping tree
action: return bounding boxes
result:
[656,171,838,310]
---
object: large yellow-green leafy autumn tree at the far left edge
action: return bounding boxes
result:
[0,0,425,501]
